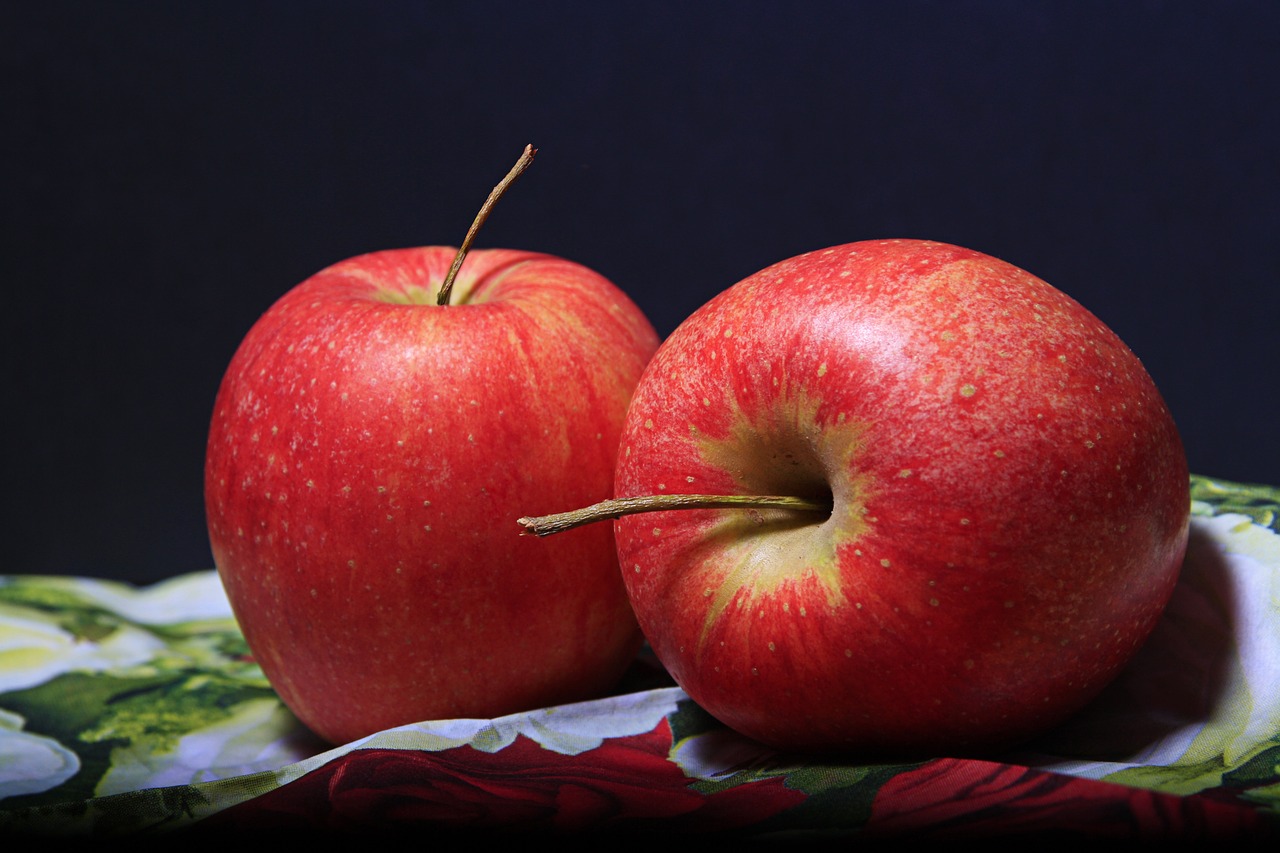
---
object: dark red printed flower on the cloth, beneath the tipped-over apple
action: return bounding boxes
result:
[867,758,1270,840]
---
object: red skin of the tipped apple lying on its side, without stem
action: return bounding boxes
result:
[614,240,1190,756]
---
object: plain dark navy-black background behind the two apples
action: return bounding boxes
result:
[0,0,1280,581]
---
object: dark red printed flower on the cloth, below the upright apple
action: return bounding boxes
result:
[200,720,805,831]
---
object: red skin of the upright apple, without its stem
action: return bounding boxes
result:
[205,246,658,743]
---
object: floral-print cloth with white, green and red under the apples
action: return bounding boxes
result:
[0,476,1280,840]
